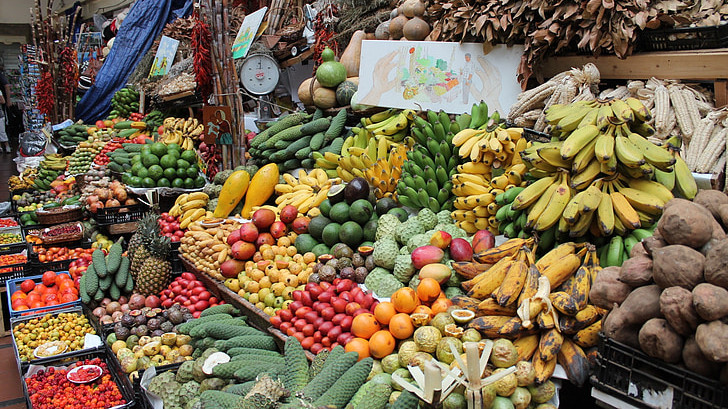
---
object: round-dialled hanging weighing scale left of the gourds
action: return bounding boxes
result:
[239,52,281,122]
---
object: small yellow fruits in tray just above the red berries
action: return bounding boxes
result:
[13,312,96,362]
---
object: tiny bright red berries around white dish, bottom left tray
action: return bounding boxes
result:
[25,358,126,409]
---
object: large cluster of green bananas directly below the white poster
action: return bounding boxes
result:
[397,111,460,213]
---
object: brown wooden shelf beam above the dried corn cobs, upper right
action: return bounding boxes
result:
[541,48,728,107]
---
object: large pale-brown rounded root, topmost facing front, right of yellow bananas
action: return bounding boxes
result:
[657,199,713,248]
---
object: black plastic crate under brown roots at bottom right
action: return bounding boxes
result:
[592,334,728,409]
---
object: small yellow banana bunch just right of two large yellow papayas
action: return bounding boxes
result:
[274,169,341,217]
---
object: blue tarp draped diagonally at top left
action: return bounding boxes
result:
[76,0,192,123]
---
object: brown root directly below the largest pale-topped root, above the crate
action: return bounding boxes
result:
[652,244,705,289]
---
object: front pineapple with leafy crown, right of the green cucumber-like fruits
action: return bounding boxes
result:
[135,234,172,297]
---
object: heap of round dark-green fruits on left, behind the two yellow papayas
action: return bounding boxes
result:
[121,142,205,189]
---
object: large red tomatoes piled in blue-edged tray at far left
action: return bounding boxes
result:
[9,270,78,311]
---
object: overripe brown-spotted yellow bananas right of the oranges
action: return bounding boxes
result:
[453,239,605,385]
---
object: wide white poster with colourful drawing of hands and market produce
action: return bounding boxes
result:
[357,40,523,114]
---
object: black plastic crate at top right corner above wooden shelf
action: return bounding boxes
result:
[639,24,728,51]
